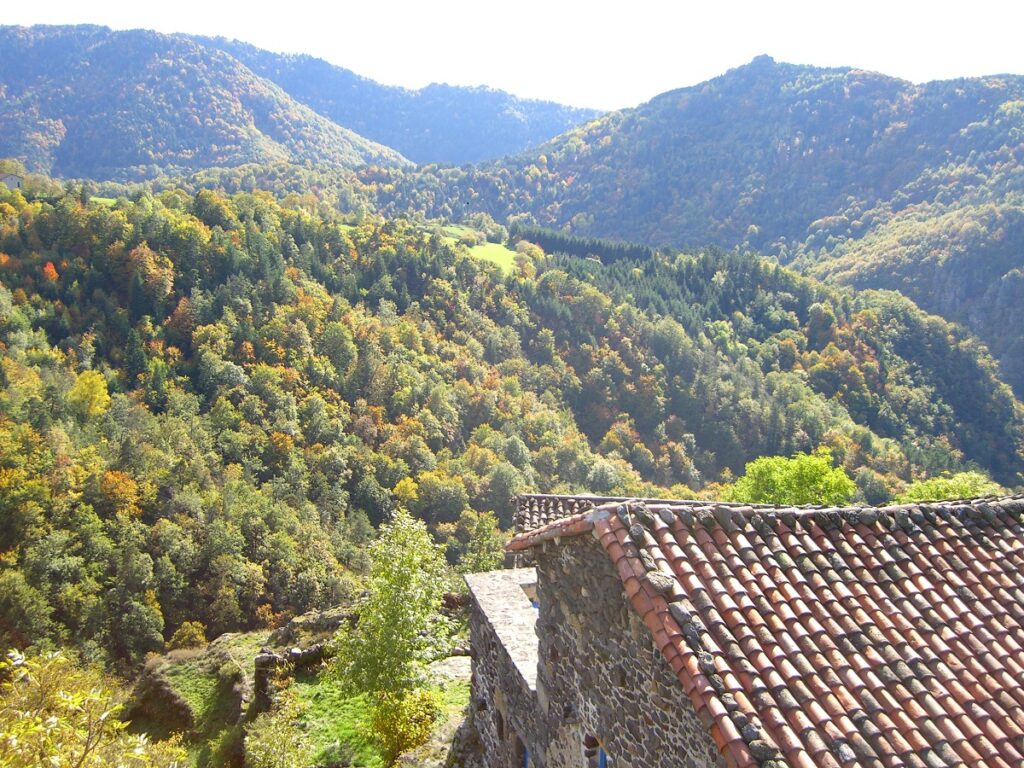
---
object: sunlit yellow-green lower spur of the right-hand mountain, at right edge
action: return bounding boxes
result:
[791,163,1024,395]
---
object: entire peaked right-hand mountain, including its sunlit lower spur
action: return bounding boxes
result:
[368,56,1024,394]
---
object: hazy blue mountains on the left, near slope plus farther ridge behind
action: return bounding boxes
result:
[0,26,598,179]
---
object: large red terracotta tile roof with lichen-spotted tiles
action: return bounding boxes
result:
[509,497,1024,768]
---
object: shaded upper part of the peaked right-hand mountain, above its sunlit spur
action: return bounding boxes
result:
[374,56,1024,252]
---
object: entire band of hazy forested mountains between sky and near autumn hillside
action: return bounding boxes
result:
[0,27,1024,396]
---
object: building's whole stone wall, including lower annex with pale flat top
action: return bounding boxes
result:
[467,536,725,768]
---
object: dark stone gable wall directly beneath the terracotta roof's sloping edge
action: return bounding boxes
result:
[532,537,724,768]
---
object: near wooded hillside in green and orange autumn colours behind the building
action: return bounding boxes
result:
[0,180,1024,665]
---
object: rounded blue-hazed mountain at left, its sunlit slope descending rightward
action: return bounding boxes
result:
[0,27,408,179]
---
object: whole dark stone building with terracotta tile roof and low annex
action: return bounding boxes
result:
[467,497,1024,768]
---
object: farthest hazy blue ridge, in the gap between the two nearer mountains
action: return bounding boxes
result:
[194,37,600,165]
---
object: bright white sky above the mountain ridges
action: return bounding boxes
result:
[0,0,1024,110]
